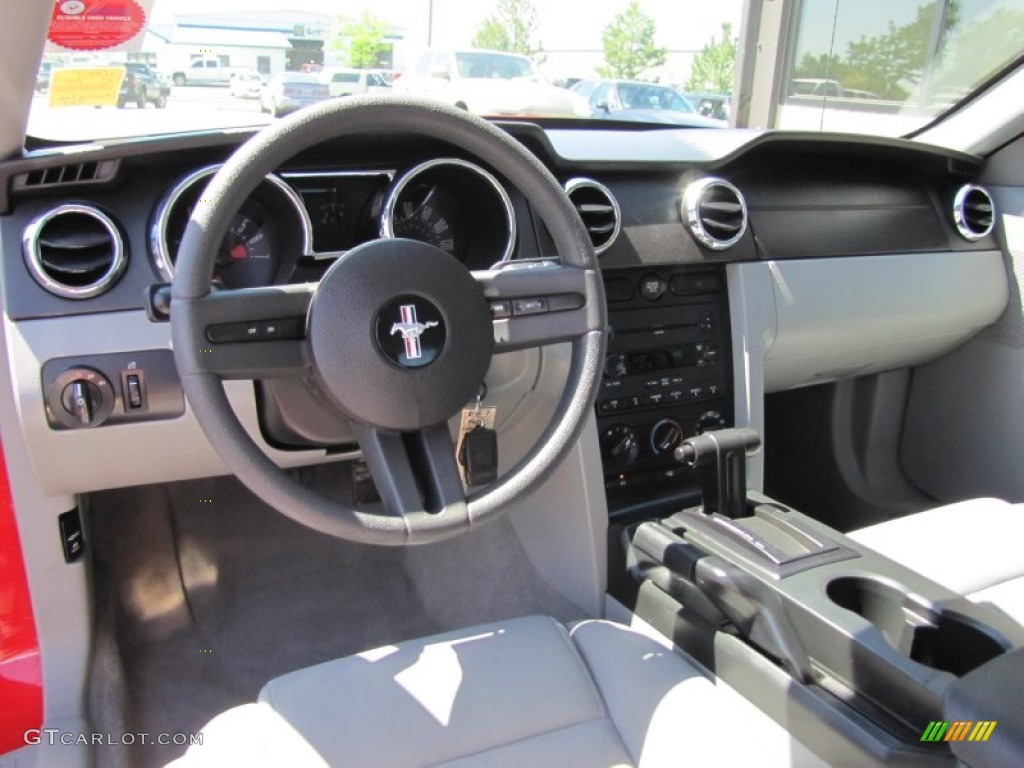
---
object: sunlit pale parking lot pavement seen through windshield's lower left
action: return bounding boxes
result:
[29,86,272,140]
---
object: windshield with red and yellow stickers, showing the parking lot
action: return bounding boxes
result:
[29,0,1024,141]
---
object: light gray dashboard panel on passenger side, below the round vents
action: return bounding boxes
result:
[764,251,1009,392]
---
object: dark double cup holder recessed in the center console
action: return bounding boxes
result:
[826,577,1009,676]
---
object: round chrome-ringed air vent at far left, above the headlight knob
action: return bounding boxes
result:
[23,205,127,299]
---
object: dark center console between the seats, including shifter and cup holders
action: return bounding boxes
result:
[609,428,1024,766]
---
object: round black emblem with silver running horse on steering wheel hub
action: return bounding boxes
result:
[375,296,447,368]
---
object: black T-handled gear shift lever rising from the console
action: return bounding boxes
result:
[675,427,761,520]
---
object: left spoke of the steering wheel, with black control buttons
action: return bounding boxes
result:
[172,285,314,379]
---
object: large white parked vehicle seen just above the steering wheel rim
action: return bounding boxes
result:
[394,50,579,116]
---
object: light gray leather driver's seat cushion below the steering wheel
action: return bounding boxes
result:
[167,616,823,768]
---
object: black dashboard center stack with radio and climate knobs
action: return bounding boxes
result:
[596,265,732,516]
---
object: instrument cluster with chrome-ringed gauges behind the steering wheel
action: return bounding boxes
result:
[150,158,516,288]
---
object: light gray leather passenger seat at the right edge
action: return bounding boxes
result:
[849,499,1024,624]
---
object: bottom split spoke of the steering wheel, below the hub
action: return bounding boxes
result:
[353,423,469,538]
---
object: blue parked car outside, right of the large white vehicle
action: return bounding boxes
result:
[569,80,725,128]
